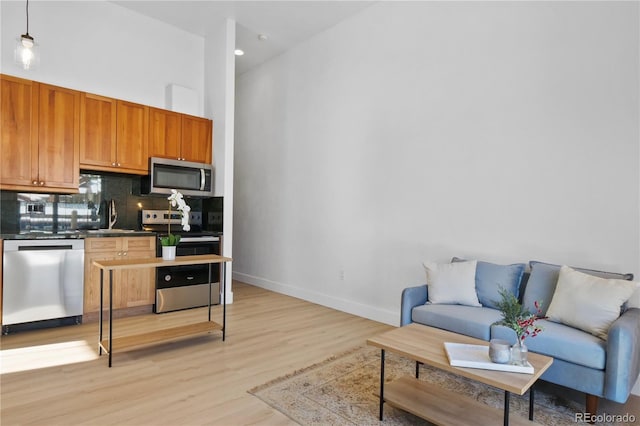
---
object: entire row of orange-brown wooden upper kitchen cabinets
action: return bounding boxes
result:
[0,74,213,183]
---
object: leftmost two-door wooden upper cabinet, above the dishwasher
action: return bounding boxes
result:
[0,75,80,193]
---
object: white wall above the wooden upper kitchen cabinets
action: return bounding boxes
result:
[0,1,204,114]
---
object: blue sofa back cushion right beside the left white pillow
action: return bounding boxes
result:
[451,257,527,309]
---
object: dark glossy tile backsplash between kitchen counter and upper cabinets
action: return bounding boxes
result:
[0,173,222,234]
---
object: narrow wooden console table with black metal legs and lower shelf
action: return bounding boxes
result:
[93,254,232,367]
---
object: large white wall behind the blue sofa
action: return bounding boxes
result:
[234,2,640,324]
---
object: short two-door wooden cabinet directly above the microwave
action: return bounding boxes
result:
[149,108,213,164]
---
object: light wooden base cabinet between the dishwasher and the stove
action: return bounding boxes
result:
[84,237,156,314]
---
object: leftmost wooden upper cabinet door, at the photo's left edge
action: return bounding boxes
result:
[0,75,38,189]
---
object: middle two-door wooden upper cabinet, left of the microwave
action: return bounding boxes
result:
[80,93,149,175]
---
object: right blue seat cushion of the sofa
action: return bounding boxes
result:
[491,320,607,370]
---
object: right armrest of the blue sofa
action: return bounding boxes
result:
[604,308,640,403]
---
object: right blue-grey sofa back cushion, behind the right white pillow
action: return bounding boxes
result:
[522,260,633,315]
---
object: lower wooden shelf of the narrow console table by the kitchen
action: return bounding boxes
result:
[100,321,222,353]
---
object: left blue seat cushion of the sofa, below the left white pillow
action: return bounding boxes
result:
[411,305,502,341]
